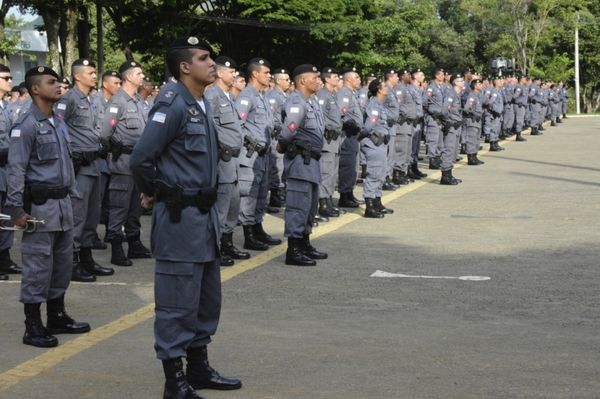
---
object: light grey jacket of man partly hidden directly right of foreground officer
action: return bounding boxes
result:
[204,85,243,183]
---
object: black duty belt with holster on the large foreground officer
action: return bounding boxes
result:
[155,180,217,223]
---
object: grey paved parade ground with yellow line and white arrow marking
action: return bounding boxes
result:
[0,117,600,399]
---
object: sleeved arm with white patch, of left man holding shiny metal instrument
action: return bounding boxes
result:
[4,124,35,220]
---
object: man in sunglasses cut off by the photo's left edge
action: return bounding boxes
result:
[0,64,21,280]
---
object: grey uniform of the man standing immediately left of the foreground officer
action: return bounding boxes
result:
[101,88,146,240]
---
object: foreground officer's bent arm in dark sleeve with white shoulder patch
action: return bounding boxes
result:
[129,104,180,197]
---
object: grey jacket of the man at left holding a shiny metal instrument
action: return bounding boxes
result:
[4,103,79,232]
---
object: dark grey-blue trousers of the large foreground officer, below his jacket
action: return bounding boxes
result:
[154,259,221,360]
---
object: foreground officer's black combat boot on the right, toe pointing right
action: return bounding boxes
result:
[186,346,242,391]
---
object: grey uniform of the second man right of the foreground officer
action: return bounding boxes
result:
[235,85,273,226]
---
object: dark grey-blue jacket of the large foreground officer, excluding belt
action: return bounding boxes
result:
[131,83,220,263]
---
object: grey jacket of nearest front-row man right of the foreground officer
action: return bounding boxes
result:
[280,90,325,183]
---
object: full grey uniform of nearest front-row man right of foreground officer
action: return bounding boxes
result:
[281,91,325,238]
